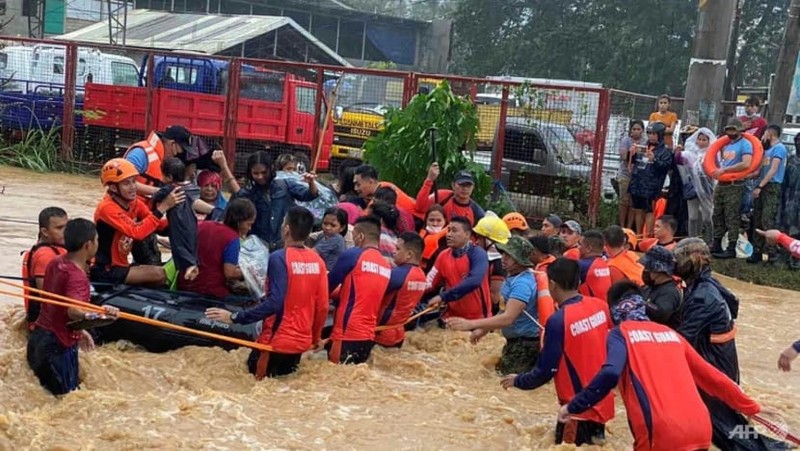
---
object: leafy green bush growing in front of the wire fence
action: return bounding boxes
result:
[364,82,492,203]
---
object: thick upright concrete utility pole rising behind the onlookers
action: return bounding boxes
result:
[683,0,738,131]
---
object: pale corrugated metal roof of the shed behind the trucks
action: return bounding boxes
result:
[56,9,350,66]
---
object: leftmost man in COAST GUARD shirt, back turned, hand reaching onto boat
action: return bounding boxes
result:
[206,207,328,379]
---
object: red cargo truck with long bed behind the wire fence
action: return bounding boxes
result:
[83,56,333,171]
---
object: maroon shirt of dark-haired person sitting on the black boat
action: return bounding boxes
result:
[178,221,239,298]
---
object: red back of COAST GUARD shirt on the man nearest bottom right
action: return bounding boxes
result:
[618,321,711,450]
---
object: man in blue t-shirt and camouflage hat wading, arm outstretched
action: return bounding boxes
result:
[447,236,539,375]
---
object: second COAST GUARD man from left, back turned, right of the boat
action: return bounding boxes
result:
[328,216,392,364]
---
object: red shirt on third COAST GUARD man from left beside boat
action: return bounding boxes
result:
[375,266,428,346]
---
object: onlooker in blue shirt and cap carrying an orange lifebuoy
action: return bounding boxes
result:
[711,118,753,258]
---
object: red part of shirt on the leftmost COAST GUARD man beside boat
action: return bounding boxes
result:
[258,247,328,354]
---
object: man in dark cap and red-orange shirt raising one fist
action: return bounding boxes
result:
[416,163,484,226]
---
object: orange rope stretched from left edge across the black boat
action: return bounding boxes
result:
[0,280,272,352]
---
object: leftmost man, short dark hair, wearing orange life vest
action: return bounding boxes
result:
[22,207,69,329]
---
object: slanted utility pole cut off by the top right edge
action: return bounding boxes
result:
[766,0,800,124]
